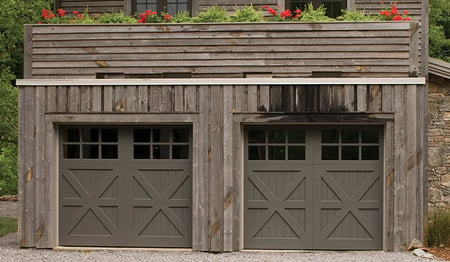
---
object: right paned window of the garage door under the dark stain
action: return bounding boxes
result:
[321,129,380,160]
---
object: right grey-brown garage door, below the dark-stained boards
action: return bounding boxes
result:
[244,126,383,249]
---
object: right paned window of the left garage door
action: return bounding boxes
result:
[133,127,189,159]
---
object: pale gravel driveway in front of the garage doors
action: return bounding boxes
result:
[0,201,440,262]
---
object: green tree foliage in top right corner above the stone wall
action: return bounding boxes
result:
[429,0,450,62]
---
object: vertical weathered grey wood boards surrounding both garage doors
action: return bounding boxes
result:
[18,80,426,252]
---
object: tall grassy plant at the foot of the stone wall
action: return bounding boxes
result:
[426,211,450,247]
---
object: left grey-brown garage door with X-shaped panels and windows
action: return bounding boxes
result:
[59,126,192,247]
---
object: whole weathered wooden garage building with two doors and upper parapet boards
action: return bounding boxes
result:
[17,1,427,252]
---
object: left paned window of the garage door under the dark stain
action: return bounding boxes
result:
[248,128,306,160]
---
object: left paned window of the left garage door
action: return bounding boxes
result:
[63,128,118,159]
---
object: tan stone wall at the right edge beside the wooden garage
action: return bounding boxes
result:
[428,75,450,210]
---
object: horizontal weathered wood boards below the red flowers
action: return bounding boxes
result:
[25,22,418,79]
